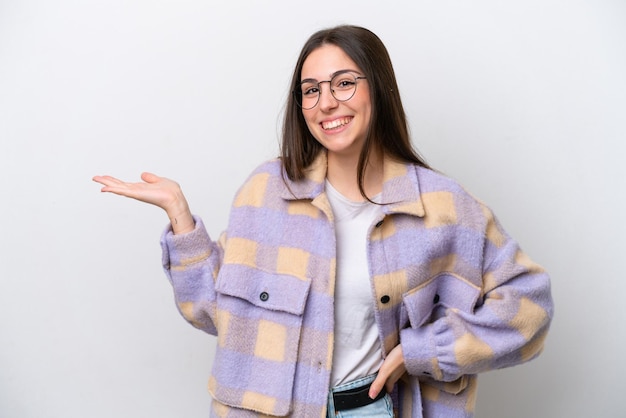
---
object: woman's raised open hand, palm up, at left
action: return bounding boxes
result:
[93,173,195,234]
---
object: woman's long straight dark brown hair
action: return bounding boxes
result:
[281,25,428,200]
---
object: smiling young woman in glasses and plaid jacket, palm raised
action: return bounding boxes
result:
[94,26,553,417]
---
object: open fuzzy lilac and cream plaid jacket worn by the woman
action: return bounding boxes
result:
[161,153,553,418]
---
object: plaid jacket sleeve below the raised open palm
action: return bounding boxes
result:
[161,217,225,335]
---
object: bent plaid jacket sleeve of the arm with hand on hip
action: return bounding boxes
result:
[400,207,553,382]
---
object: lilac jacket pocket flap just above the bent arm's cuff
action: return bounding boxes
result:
[402,273,481,328]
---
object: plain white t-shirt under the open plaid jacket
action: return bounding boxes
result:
[326,181,383,386]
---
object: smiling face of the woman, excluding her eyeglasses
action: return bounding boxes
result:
[300,44,372,158]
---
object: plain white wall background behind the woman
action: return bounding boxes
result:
[0,0,626,418]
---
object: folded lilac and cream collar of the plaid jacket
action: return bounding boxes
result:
[281,152,425,217]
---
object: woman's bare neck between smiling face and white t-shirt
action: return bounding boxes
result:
[326,152,383,202]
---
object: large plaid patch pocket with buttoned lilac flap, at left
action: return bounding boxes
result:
[209,264,310,416]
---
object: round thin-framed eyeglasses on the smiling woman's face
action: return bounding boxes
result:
[293,71,367,110]
